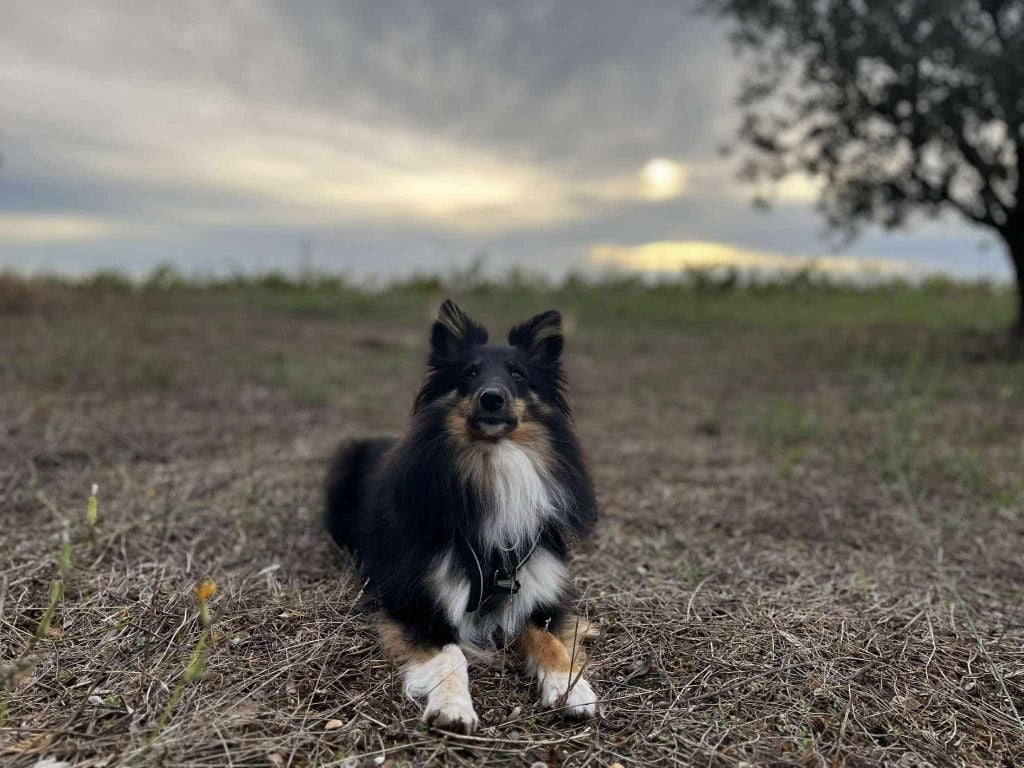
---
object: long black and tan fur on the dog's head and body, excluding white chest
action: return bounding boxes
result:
[327,301,597,647]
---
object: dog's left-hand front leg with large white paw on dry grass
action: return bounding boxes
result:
[380,618,479,733]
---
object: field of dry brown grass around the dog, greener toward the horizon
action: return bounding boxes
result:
[0,275,1024,768]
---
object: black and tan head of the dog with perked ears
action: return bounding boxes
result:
[414,300,569,440]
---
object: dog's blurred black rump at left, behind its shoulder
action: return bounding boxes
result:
[324,437,394,551]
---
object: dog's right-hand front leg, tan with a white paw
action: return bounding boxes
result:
[516,618,597,719]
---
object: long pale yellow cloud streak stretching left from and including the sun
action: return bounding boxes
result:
[0,47,696,233]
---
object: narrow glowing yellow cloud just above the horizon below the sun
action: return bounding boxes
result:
[588,241,913,275]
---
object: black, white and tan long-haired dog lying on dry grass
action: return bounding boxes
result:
[326,300,597,733]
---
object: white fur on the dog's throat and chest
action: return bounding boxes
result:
[430,440,567,644]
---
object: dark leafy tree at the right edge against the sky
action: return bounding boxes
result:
[705,0,1024,351]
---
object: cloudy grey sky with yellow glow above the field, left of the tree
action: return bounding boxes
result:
[0,0,1009,279]
